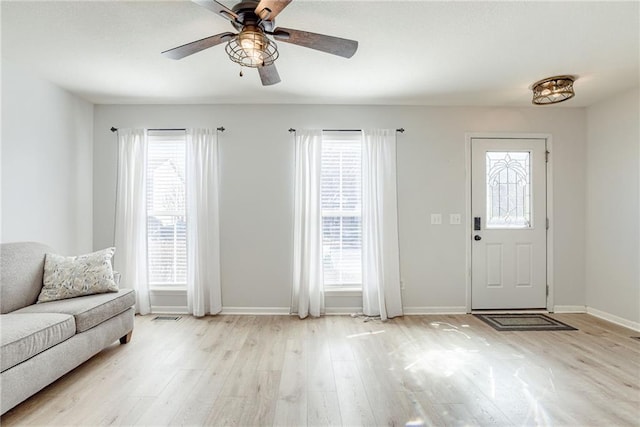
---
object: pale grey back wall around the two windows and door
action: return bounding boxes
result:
[93,105,586,312]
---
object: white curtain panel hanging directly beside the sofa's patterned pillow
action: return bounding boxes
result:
[114,129,151,314]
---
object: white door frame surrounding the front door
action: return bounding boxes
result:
[464,132,555,313]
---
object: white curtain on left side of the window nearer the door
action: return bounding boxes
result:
[291,130,324,319]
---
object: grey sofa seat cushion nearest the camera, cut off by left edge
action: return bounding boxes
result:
[0,313,76,372]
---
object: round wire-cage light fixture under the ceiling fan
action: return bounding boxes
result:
[225,25,279,68]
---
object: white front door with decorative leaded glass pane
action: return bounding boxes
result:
[471,138,547,310]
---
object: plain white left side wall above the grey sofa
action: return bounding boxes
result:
[1,61,93,254]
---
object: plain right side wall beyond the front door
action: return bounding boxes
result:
[585,90,640,328]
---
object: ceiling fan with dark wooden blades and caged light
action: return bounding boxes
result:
[162,0,358,86]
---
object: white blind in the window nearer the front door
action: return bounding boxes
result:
[320,132,362,286]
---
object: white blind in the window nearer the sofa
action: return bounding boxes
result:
[147,131,187,286]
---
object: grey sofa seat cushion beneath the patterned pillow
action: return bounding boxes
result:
[15,289,136,333]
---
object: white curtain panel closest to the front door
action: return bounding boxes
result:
[362,129,403,320]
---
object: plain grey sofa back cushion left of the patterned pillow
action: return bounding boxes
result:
[0,242,52,314]
